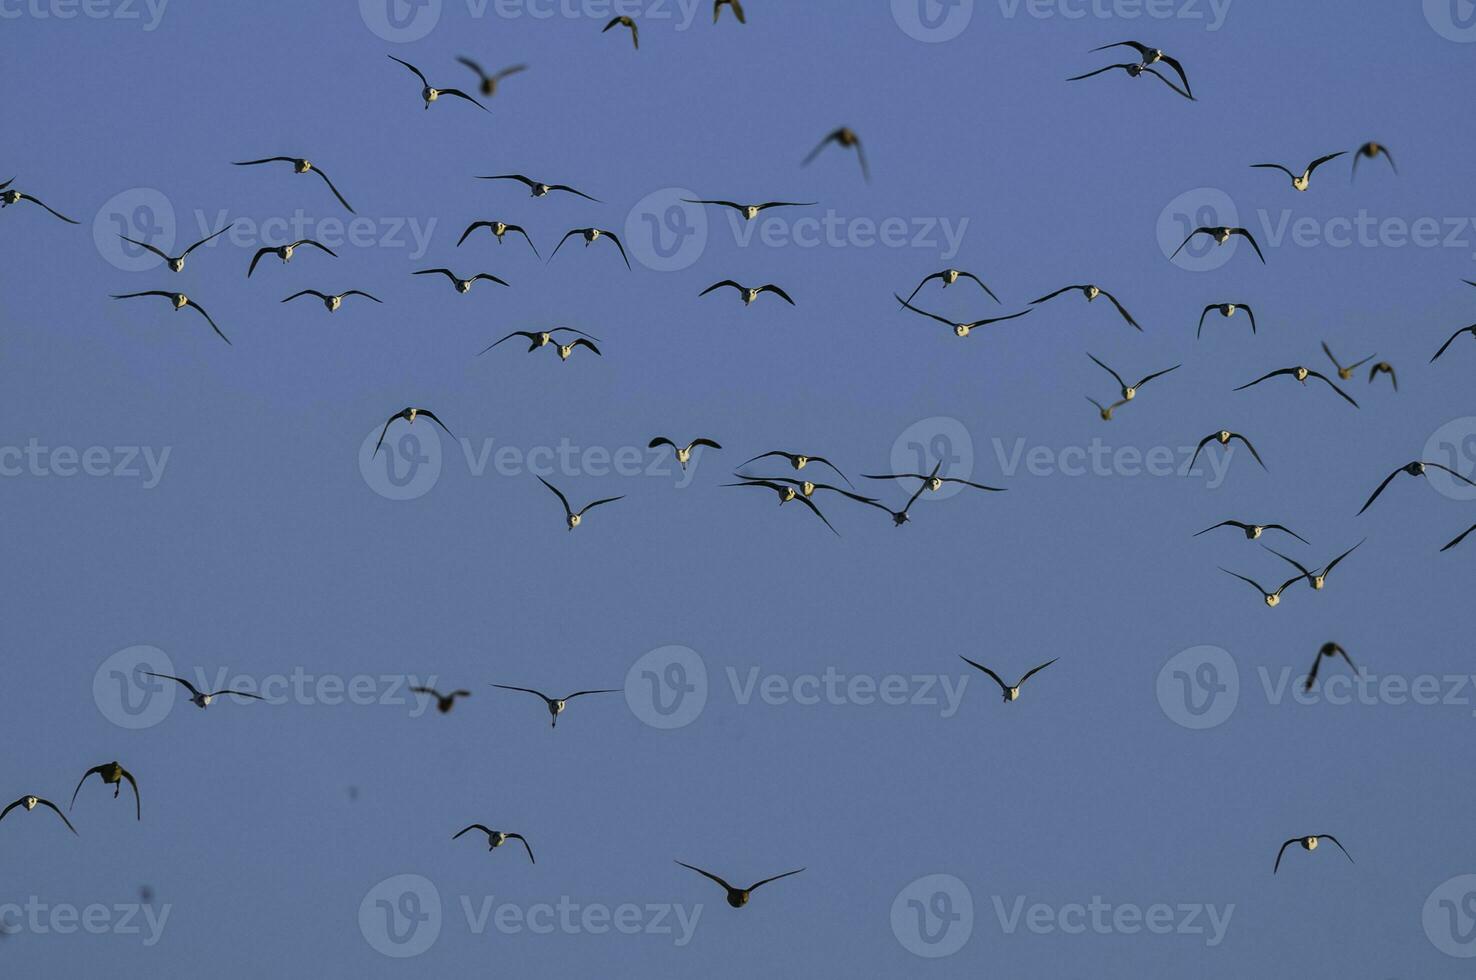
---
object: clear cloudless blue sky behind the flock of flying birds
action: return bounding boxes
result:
[0,0,1476,980]
